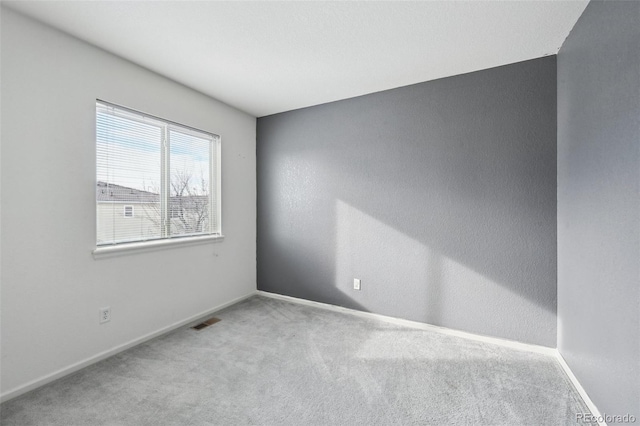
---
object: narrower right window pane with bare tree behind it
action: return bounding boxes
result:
[169,128,214,236]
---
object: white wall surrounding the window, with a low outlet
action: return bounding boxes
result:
[0,8,256,399]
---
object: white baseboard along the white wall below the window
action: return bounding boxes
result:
[0,292,256,402]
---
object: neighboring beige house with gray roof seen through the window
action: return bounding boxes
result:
[96,181,209,245]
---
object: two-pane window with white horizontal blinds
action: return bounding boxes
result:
[96,101,220,247]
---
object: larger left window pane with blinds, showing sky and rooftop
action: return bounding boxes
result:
[96,104,162,245]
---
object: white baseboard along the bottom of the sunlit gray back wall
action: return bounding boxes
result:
[257,290,557,357]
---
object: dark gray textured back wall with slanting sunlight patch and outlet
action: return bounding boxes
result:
[257,57,556,347]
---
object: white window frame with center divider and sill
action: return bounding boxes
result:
[92,99,224,259]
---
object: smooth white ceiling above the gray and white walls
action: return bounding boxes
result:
[3,0,588,117]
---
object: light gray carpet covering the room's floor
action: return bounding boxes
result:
[0,296,588,426]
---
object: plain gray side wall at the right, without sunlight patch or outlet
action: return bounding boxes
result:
[558,1,640,421]
